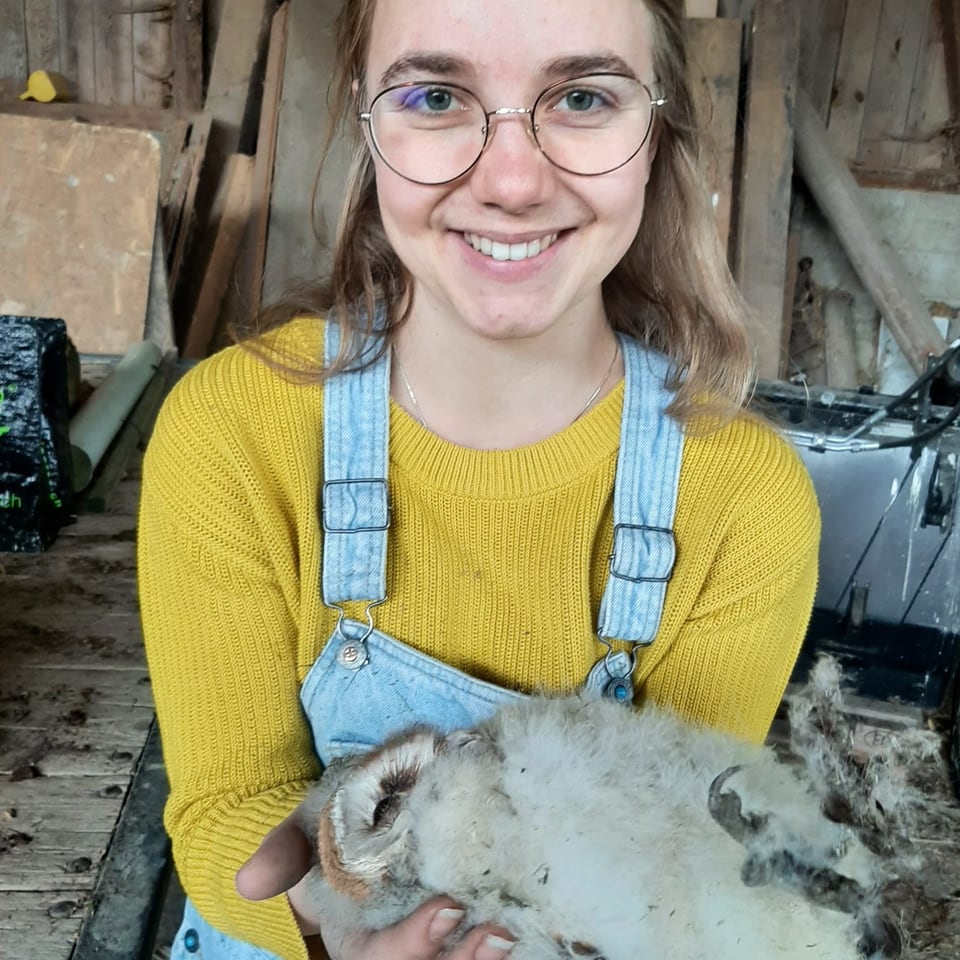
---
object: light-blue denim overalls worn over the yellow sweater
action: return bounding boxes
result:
[171,324,683,960]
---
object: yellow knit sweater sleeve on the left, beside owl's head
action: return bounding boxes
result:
[138,350,319,960]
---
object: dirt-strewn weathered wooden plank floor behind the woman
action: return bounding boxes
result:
[0,460,960,960]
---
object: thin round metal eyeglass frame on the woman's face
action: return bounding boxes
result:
[357,70,668,187]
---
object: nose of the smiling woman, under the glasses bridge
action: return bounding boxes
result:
[470,107,555,212]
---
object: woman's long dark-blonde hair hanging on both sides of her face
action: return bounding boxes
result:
[251,0,752,424]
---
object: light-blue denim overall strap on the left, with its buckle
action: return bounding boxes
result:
[320,316,390,606]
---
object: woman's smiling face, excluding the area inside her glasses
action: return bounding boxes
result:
[362,0,655,339]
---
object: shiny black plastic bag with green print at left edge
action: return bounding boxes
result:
[0,314,72,553]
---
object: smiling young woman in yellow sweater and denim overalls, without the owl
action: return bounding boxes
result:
[139,0,819,960]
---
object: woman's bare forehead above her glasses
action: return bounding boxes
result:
[367,0,653,89]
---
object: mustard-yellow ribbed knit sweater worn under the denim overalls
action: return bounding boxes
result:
[138,321,819,958]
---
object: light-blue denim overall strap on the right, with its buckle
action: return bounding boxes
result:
[597,336,683,644]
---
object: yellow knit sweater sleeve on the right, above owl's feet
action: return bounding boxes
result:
[639,418,820,742]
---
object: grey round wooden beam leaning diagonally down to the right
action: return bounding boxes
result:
[796,91,946,374]
